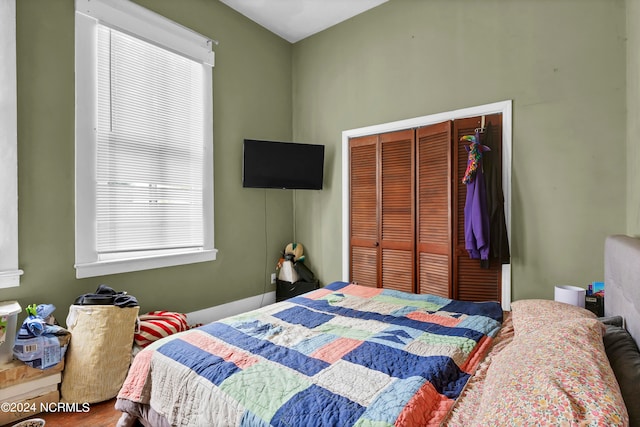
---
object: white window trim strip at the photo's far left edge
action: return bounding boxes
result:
[0,0,23,288]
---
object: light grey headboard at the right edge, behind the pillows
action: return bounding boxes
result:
[604,235,640,343]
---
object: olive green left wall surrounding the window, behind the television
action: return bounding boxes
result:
[0,0,293,323]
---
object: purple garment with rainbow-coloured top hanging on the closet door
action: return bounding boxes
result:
[461,132,490,268]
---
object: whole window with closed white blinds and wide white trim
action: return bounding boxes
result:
[76,0,216,278]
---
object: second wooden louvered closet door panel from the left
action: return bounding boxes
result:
[380,129,415,292]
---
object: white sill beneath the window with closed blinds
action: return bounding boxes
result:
[75,249,218,279]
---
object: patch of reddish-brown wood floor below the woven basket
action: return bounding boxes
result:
[5,399,121,427]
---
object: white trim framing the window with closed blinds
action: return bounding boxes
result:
[75,0,217,278]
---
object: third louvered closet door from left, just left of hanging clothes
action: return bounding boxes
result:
[416,121,452,298]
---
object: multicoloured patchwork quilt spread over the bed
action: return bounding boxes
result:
[118,282,502,427]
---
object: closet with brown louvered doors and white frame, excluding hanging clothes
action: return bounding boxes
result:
[342,100,512,309]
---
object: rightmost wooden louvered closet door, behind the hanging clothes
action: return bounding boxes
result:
[453,114,502,301]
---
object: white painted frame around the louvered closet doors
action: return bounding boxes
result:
[342,100,513,310]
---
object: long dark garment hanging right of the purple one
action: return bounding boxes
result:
[482,122,511,264]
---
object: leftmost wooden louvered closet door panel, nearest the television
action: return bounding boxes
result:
[349,135,380,288]
